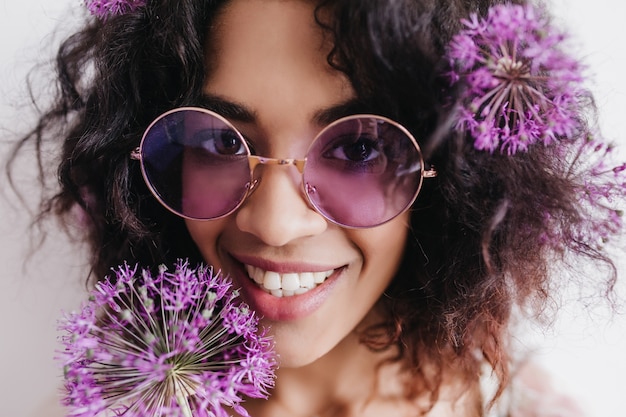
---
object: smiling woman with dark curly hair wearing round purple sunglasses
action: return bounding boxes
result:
[11,0,624,417]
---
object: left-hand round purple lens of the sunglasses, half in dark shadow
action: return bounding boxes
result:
[141,108,250,220]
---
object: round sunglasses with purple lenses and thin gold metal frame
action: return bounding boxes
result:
[131,107,437,228]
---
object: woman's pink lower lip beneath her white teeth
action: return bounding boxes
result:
[229,264,344,321]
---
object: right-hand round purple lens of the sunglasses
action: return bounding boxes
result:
[304,116,423,227]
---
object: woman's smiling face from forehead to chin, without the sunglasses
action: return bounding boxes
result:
[186,0,408,367]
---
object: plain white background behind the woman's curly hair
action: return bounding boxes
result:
[0,0,626,417]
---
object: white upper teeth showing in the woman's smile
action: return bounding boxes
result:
[244,265,335,297]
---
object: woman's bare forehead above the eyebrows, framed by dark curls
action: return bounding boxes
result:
[204,0,353,133]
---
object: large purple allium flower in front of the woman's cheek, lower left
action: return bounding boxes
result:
[59,261,276,417]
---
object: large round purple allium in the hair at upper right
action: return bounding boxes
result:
[447,4,582,154]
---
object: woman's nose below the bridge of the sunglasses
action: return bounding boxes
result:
[236,165,328,247]
